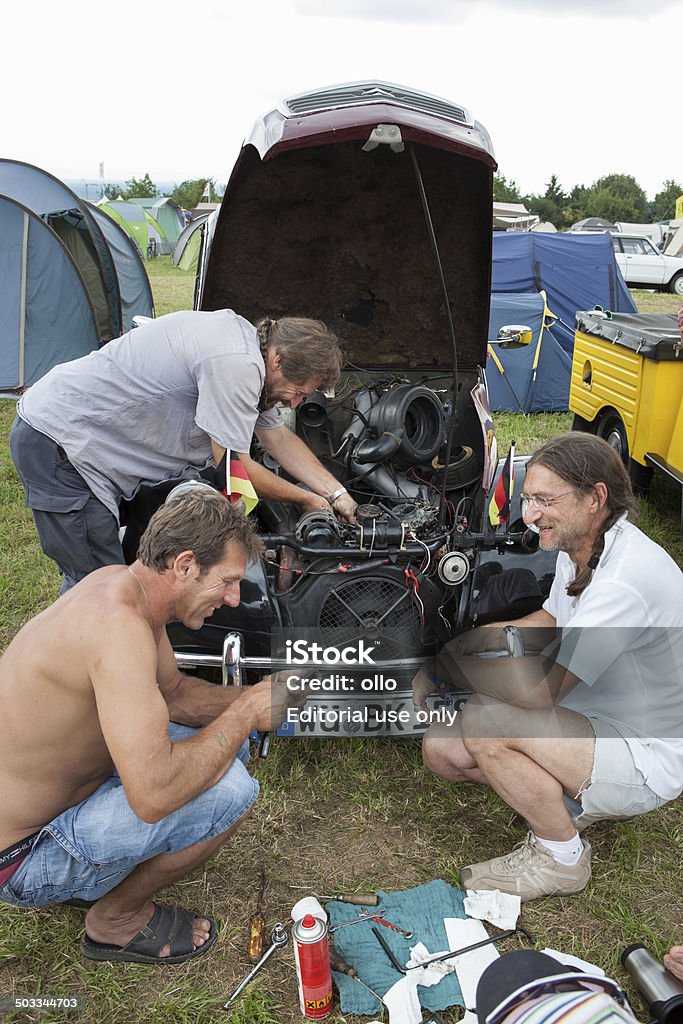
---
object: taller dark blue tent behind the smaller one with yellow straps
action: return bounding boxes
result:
[488,231,637,353]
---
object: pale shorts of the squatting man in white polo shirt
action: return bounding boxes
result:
[565,719,667,828]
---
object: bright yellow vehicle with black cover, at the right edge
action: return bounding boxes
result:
[569,308,683,531]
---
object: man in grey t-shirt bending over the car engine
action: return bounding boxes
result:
[10,309,355,590]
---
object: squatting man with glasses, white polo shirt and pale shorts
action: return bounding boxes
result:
[414,432,683,900]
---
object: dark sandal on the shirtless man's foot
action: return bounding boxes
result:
[81,904,218,964]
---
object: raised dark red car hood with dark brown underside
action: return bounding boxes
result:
[199,82,496,371]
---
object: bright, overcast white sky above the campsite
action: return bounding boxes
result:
[0,0,683,199]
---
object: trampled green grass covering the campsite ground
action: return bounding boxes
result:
[0,266,683,1024]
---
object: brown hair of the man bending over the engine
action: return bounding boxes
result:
[256,316,344,389]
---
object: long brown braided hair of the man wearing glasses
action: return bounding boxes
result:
[526,430,635,597]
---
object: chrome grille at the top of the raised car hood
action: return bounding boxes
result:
[284,82,473,127]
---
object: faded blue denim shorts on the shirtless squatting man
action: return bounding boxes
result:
[0,723,258,906]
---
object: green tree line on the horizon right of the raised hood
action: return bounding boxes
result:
[494,174,683,230]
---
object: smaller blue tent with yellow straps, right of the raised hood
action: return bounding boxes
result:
[486,292,571,413]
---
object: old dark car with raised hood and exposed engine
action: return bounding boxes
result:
[121,82,552,732]
